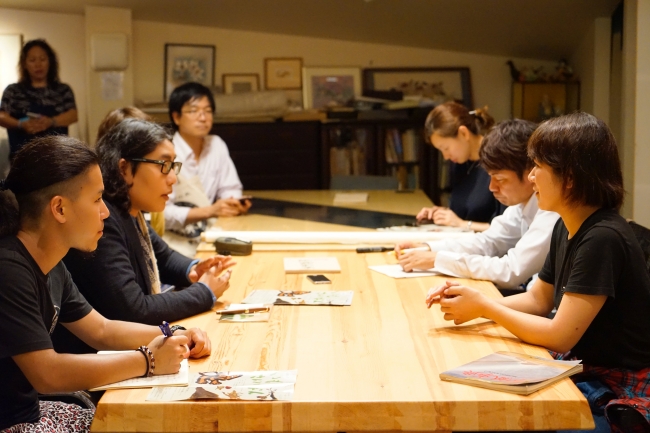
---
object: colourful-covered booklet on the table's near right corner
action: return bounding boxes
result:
[440,352,582,395]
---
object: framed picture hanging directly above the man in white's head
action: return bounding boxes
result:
[164,44,216,100]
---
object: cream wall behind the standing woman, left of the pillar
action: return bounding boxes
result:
[0,8,88,141]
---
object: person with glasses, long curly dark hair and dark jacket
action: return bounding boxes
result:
[55,119,234,352]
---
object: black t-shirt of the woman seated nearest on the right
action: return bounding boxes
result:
[539,209,650,370]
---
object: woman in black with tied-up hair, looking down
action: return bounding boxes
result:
[416,102,506,232]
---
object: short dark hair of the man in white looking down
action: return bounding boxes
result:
[479,119,537,180]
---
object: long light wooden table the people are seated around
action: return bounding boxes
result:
[92,191,593,432]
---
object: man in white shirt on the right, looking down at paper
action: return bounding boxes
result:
[395,119,559,289]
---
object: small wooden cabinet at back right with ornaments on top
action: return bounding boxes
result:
[512,82,580,122]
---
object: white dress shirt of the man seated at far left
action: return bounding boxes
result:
[165,132,243,229]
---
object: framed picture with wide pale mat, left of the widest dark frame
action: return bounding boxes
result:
[302,67,361,109]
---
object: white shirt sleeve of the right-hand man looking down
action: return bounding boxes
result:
[426,210,559,288]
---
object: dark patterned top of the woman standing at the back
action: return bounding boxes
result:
[0,83,77,155]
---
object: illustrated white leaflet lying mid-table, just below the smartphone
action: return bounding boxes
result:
[242,290,354,305]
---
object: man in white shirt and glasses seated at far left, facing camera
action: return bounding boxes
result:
[165,83,251,230]
